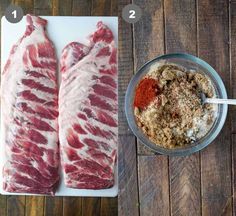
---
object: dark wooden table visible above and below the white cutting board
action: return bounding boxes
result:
[0,0,118,216]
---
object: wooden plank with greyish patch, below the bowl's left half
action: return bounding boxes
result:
[138,155,169,216]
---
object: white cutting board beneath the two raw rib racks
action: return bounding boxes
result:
[0,16,118,197]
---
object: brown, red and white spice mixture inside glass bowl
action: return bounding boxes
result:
[134,64,217,148]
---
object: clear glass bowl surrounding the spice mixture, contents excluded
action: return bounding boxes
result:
[125,53,228,156]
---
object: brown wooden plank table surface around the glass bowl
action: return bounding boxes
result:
[118,0,236,216]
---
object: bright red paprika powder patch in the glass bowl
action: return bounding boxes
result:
[134,78,160,109]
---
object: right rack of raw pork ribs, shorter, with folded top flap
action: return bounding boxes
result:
[59,22,118,189]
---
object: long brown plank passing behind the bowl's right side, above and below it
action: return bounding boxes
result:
[198,0,232,216]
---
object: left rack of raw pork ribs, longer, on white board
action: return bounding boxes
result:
[2,15,59,195]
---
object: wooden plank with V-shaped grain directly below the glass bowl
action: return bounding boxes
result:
[169,153,201,215]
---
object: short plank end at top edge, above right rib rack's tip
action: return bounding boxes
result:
[91,0,111,16]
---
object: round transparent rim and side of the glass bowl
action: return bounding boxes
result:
[125,53,228,156]
